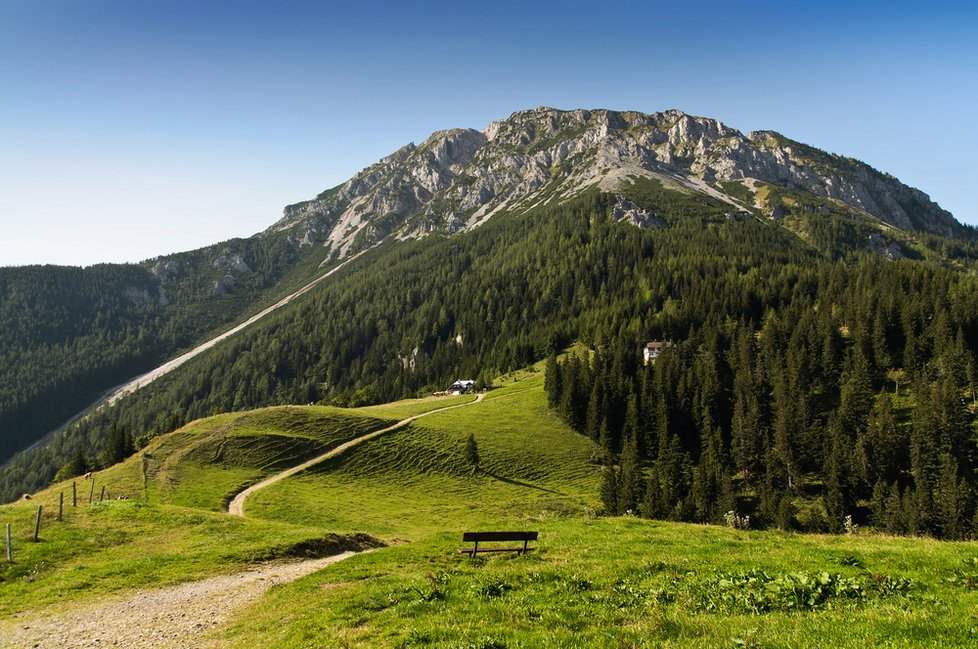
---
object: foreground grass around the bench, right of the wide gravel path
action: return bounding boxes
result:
[221,517,978,649]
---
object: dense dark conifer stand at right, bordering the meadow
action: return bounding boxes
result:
[546,258,978,539]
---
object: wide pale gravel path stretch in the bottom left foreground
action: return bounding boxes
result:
[0,552,356,649]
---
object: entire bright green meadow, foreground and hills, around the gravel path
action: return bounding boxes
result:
[0,372,978,649]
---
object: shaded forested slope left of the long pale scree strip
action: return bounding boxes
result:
[0,228,327,470]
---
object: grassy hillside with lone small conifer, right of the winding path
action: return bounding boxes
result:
[248,372,599,540]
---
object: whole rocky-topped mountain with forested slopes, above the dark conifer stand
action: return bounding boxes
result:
[0,109,978,507]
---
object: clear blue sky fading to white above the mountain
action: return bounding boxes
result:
[0,0,978,266]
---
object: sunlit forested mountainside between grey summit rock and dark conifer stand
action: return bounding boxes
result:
[3,183,978,506]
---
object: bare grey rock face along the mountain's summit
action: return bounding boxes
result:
[264,108,962,256]
